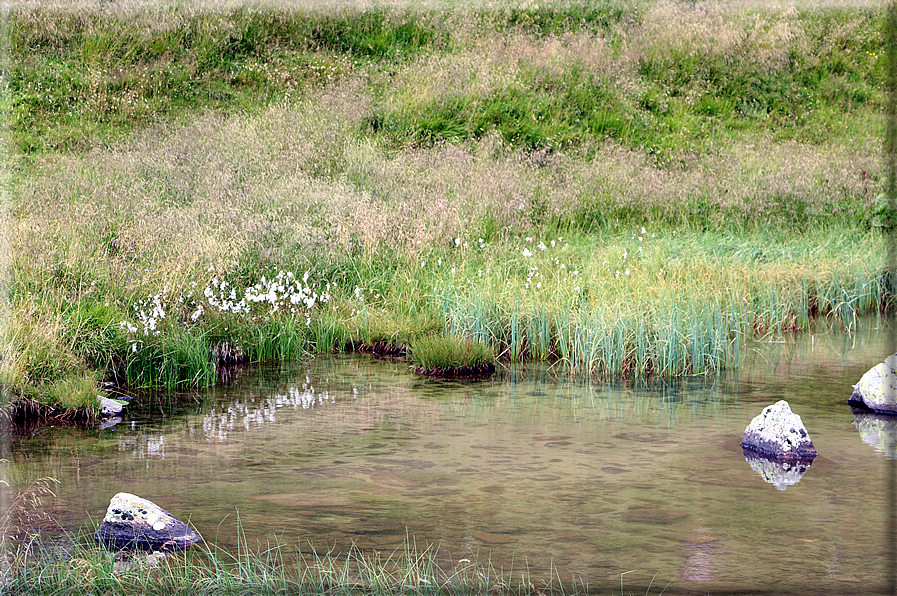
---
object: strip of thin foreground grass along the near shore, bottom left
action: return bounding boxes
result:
[5,536,586,596]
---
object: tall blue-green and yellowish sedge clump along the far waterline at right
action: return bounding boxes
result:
[437,227,887,378]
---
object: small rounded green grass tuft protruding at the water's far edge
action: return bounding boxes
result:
[409,336,495,376]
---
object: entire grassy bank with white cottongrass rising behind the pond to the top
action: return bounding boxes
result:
[0,3,889,420]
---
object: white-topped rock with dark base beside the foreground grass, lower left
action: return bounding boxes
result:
[94,493,202,553]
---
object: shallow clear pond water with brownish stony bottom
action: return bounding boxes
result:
[5,324,894,594]
